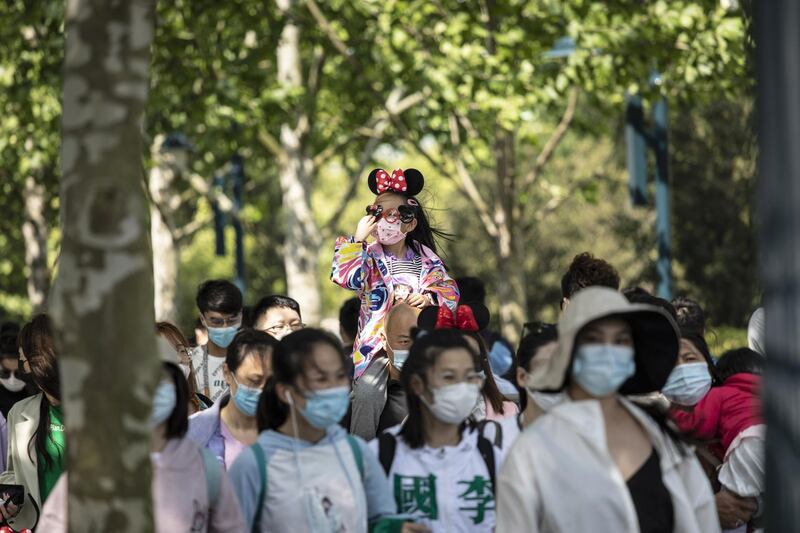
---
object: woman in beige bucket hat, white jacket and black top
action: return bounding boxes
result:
[496,287,720,533]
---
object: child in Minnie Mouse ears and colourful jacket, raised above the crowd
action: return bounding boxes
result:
[331,168,458,378]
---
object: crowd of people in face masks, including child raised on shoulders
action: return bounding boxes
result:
[0,169,765,533]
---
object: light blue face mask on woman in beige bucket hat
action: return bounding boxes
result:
[572,344,636,398]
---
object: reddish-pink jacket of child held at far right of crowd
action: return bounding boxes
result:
[671,374,764,451]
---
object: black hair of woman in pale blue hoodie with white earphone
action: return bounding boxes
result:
[256,328,347,432]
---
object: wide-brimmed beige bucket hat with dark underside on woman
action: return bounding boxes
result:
[528,287,680,394]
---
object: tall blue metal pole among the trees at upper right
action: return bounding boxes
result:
[653,96,672,300]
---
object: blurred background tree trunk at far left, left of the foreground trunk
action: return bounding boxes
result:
[22,176,50,313]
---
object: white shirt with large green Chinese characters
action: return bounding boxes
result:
[369,426,502,533]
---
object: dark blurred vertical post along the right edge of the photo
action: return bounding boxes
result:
[753,0,800,532]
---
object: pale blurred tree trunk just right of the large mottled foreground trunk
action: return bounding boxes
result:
[149,136,180,323]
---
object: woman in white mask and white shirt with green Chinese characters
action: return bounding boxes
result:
[370,329,503,533]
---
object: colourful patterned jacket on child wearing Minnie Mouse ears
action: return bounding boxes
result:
[331,237,459,378]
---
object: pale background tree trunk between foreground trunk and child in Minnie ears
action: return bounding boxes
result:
[277,0,322,324]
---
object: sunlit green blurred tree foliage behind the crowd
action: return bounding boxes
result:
[0,0,760,344]
